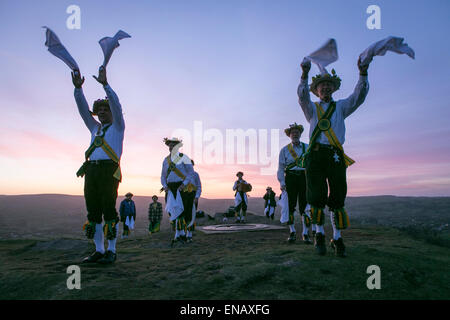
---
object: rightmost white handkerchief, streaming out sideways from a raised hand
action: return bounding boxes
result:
[359,36,415,65]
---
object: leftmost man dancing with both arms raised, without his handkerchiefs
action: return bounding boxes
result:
[72,67,125,264]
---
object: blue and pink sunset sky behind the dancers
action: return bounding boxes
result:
[0,0,450,198]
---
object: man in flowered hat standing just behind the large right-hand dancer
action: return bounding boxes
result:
[277,123,311,244]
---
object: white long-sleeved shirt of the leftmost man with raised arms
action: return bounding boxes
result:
[74,85,125,160]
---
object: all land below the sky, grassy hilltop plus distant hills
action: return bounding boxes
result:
[0,195,450,300]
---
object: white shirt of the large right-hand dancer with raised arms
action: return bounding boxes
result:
[297,76,369,145]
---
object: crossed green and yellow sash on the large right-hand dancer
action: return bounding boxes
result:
[306,101,355,167]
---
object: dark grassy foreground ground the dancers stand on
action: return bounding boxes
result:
[0,222,450,300]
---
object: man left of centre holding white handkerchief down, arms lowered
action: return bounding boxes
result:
[161,138,195,245]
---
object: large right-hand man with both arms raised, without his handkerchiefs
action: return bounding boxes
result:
[298,60,369,257]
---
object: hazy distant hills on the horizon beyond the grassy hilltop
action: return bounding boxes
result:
[0,194,450,239]
